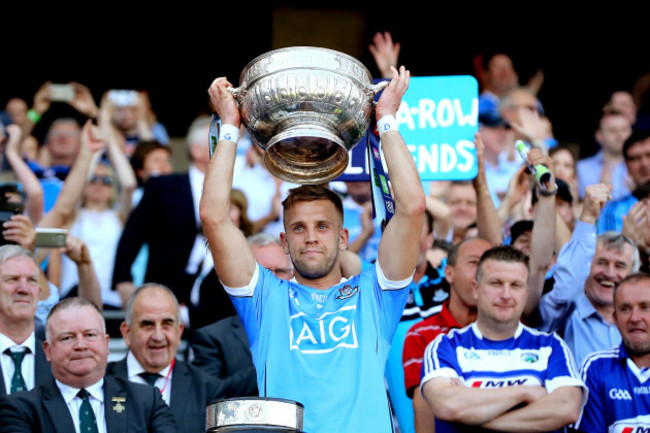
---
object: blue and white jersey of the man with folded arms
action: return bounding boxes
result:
[420,323,586,433]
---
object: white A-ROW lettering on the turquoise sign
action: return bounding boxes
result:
[396,98,478,131]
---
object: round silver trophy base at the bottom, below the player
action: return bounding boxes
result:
[206,397,304,433]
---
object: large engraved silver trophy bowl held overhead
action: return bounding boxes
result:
[231,47,388,184]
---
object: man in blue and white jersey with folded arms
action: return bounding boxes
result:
[420,246,586,433]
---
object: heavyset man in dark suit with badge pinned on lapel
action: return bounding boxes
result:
[0,298,176,433]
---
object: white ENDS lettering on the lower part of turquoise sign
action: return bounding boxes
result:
[407,140,475,173]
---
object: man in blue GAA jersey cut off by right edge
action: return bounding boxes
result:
[576,273,650,433]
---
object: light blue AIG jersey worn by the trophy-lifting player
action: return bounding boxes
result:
[226,265,411,433]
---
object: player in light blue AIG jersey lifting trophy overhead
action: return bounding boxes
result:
[200,67,425,433]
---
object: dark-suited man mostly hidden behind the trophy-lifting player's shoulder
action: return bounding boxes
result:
[192,233,293,397]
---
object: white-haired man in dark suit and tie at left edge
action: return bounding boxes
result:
[0,245,52,396]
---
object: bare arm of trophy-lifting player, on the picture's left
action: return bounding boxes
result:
[199,77,256,287]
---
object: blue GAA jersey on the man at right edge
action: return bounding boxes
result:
[576,344,650,433]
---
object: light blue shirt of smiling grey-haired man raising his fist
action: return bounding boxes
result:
[539,221,621,364]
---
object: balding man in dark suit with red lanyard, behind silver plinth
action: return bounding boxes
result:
[107,283,225,433]
